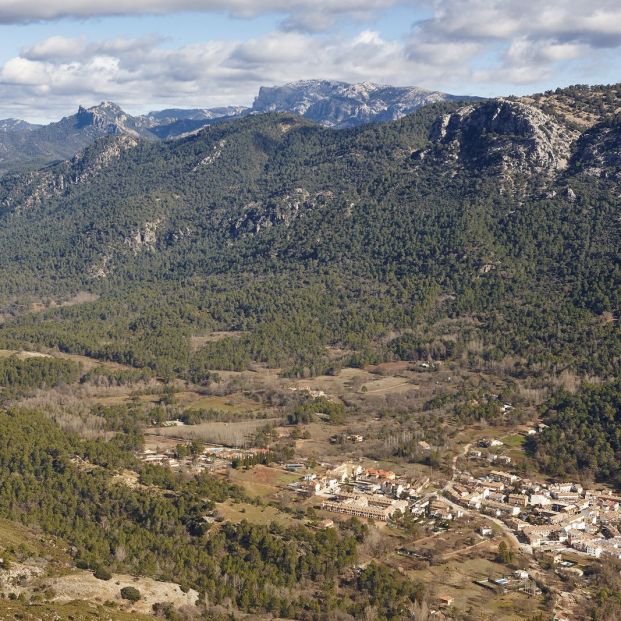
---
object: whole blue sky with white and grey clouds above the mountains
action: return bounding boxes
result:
[0,0,621,122]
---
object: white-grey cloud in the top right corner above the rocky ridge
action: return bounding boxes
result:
[409,0,621,84]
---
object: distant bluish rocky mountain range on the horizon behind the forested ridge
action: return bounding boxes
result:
[0,80,478,173]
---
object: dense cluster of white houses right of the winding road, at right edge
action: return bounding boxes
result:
[444,470,621,558]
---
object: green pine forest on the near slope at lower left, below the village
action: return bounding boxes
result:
[0,410,424,619]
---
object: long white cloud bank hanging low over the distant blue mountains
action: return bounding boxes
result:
[0,30,444,117]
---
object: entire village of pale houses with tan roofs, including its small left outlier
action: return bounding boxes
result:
[139,426,621,559]
